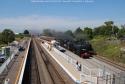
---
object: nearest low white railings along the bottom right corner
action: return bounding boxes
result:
[80,74,125,84]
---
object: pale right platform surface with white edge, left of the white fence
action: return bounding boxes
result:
[41,43,86,84]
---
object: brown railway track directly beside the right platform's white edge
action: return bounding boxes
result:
[36,38,65,84]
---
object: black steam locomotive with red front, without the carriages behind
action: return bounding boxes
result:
[60,41,96,58]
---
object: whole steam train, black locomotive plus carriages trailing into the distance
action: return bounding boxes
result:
[41,36,96,58]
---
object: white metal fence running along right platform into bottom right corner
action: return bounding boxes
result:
[46,44,125,84]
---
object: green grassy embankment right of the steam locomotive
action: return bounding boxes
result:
[90,36,125,63]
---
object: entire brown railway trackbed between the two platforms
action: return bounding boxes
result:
[22,38,66,84]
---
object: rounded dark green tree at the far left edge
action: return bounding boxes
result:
[2,29,15,44]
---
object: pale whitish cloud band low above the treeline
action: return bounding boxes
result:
[0,15,120,32]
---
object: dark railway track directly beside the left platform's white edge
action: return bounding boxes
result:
[22,42,40,84]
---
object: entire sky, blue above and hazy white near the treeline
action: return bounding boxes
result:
[0,0,125,32]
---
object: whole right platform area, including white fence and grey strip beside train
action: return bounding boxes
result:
[41,41,123,84]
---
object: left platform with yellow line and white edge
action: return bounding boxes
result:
[3,40,30,84]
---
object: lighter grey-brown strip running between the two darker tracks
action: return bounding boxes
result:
[32,39,54,84]
